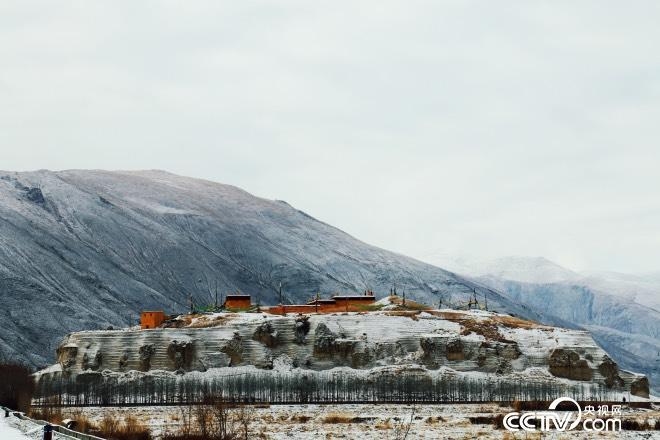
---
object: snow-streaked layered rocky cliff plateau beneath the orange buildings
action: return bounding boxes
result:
[42,312,649,396]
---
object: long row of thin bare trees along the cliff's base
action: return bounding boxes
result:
[34,371,615,406]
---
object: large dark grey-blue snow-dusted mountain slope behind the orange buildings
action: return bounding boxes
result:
[0,171,552,365]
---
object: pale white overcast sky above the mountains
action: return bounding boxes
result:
[0,0,660,272]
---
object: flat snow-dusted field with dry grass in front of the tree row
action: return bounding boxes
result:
[65,404,660,440]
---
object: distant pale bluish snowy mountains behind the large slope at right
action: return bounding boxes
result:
[432,254,660,390]
